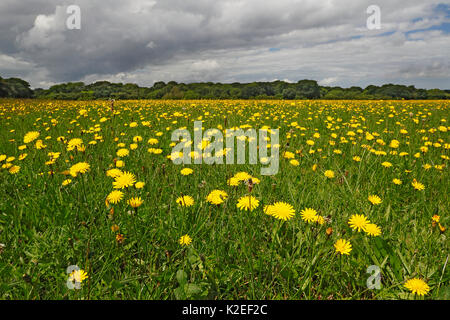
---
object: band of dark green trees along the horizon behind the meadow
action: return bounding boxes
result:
[0,77,450,100]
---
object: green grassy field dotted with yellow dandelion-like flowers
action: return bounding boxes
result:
[0,100,450,300]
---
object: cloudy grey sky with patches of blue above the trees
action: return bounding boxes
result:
[0,0,450,89]
